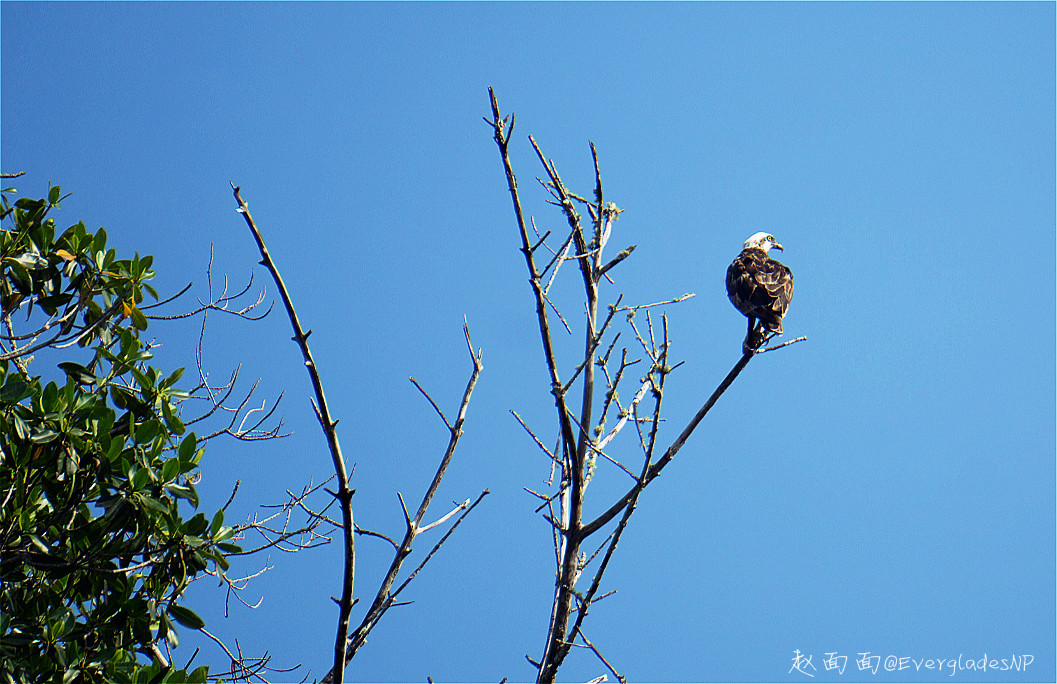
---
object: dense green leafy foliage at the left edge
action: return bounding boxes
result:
[0,181,233,682]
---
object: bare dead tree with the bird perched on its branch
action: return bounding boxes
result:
[485,88,798,682]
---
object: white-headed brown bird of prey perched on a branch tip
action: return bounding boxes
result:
[727,233,793,352]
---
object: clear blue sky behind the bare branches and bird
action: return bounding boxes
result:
[0,2,1057,682]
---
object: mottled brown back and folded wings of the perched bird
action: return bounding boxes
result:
[726,247,793,333]
